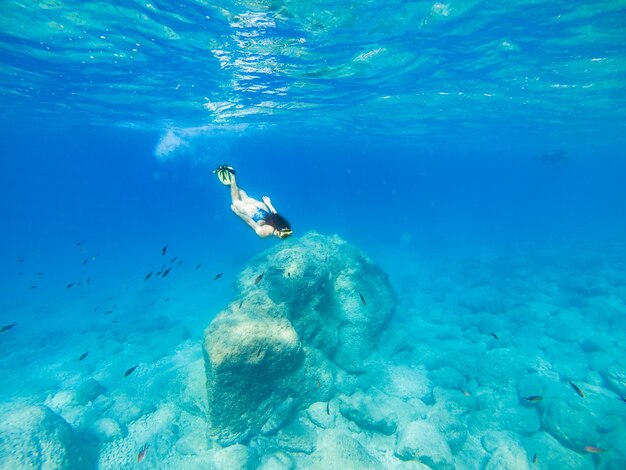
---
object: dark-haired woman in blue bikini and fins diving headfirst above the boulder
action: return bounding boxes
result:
[213,165,292,238]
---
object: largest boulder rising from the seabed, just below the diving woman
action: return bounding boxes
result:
[203,233,396,445]
